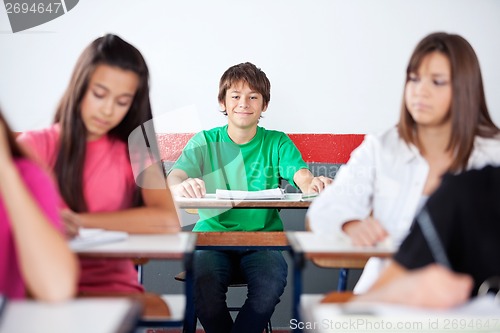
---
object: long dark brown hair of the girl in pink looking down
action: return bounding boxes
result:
[54,34,152,212]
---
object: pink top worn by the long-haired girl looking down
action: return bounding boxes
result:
[18,124,144,293]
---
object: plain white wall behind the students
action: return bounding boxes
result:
[0,0,500,133]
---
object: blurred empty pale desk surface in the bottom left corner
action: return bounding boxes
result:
[0,298,141,333]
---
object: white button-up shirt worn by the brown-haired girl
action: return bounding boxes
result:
[307,127,500,293]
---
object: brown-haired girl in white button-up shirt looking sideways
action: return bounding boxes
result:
[307,33,500,293]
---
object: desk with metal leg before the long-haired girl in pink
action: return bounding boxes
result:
[76,232,197,333]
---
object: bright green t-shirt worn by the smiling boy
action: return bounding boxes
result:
[172,125,308,231]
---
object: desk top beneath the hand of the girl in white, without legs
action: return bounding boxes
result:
[287,231,396,259]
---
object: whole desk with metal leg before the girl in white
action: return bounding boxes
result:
[286,231,396,331]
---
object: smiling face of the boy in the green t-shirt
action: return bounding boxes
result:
[220,81,267,129]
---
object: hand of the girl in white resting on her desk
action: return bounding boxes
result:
[342,216,389,246]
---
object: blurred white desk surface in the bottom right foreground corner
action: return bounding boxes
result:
[304,296,500,333]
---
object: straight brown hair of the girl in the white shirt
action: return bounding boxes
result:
[398,32,500,171]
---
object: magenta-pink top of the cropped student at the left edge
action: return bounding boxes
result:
[0,159,62,298]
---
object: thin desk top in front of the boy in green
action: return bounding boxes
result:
[174,194,312,209]
